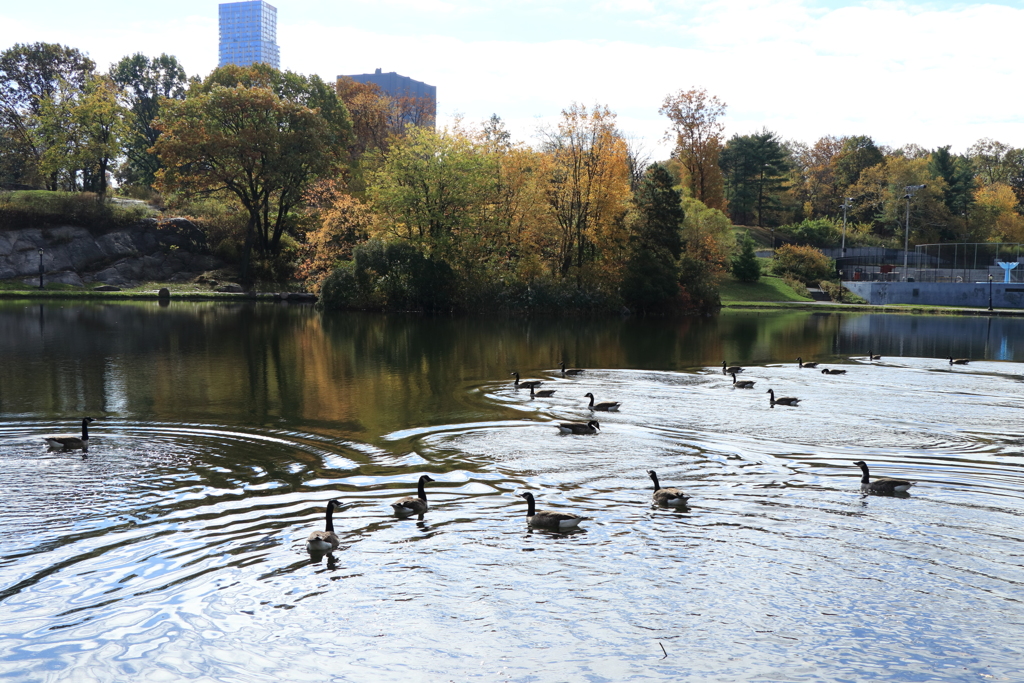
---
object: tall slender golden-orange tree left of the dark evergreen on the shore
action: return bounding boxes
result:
[543,103,630,285]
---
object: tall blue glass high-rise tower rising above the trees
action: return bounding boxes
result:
[218,0,281,69]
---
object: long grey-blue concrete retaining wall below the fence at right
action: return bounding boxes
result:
[843,281,1024,308]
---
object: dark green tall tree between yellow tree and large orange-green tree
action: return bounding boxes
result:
[110,53,188,187]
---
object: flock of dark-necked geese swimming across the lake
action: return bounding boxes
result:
[44,351,942,554]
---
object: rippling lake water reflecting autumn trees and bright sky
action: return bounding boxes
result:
[0,301,1024,682]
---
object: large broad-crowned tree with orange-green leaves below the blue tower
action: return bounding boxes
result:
[154,78,350,280]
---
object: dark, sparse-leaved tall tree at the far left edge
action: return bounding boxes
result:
[0,43,95,189]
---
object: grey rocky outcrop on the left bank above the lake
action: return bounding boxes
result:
[0,218,223,287]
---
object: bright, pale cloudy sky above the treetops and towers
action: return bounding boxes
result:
[0,0,1024,159]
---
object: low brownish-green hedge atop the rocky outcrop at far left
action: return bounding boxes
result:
[0,189,153,232]
